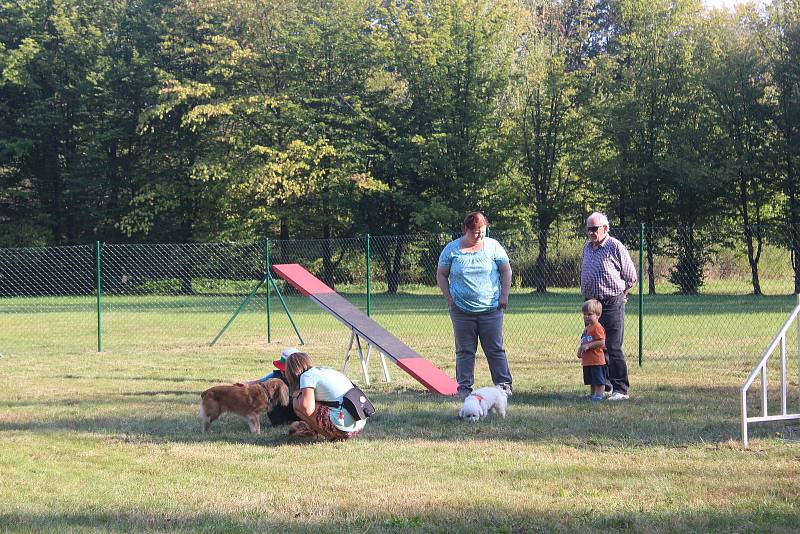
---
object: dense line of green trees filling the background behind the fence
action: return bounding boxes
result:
[0,0,800,293]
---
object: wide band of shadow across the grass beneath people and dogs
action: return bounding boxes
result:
[0,385,768,447]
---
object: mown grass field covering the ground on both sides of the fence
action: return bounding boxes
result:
[0,291,800,533]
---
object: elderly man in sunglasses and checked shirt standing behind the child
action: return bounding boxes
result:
[581,212,638,401]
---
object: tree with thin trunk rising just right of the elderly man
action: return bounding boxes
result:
[595,0,700,294]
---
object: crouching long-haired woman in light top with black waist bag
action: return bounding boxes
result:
[286,352,367,441]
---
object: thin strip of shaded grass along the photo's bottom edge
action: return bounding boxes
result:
[0,506,798,533]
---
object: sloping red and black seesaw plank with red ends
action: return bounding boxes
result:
[272,263,458,395]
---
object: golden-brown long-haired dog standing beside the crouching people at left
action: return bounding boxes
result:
[200,378,289,434]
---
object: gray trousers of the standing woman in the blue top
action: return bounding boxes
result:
[450,306,511,393]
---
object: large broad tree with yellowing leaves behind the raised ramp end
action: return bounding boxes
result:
[138,0,384,285]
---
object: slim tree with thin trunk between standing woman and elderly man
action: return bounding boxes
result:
[509,0,594,292]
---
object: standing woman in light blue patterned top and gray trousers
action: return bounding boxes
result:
[436,211,511,399]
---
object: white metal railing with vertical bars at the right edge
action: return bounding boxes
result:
[741,294,800,448]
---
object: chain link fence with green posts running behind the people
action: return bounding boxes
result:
[0,226,798,390]
